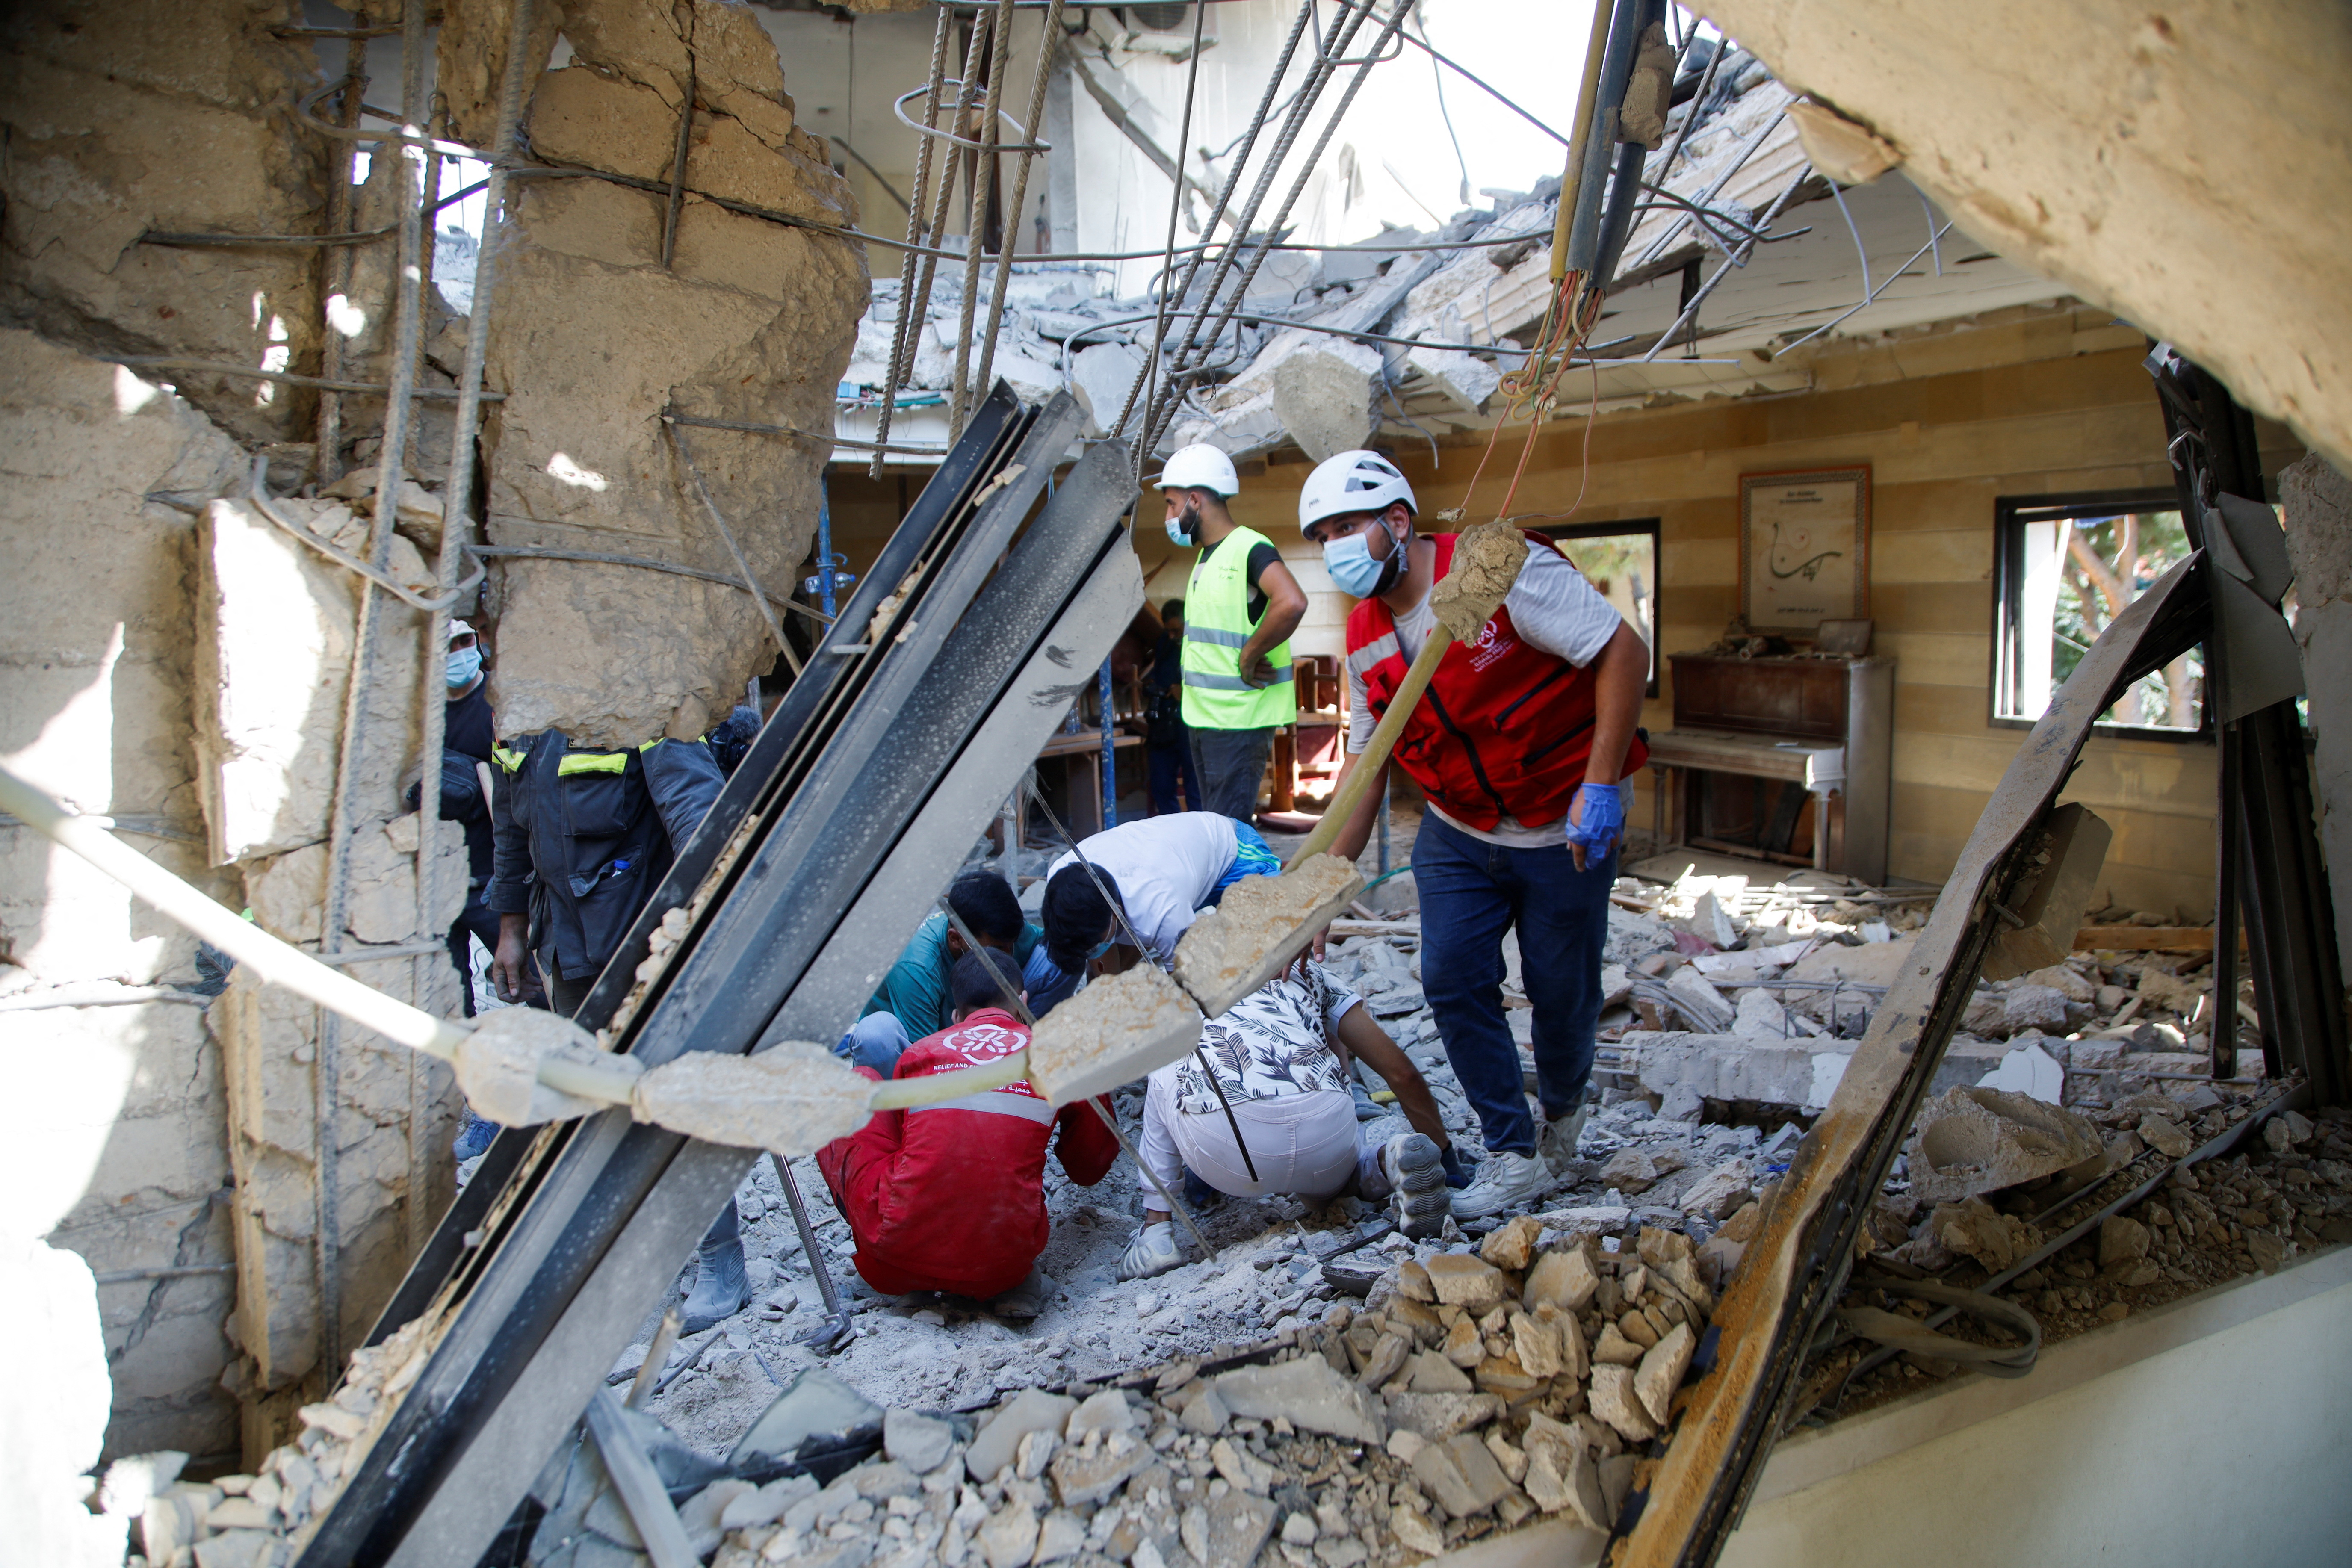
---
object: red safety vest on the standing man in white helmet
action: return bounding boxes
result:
[1348,534,1649,832]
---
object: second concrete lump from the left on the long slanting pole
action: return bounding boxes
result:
[623,1039,873,1157]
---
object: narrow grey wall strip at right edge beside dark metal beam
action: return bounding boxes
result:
[2279,452,2352,976]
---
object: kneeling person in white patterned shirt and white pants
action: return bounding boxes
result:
[1120,962,1454,1279]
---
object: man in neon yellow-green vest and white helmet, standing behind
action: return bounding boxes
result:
[1157,444,1308,823]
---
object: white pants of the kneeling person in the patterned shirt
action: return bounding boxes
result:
[1136,1065,1388,1208]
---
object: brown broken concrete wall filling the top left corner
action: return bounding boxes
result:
[0,0,327,442]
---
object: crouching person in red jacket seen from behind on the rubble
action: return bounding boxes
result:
[816,948,1120,1319]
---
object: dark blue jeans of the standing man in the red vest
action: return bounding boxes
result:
[1414,811,1616,1154]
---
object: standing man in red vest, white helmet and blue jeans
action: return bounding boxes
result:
[1298,452,1649,1220]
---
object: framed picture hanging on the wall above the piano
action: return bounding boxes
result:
[1740,463,1870,637]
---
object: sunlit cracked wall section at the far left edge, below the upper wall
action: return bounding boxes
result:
[0,331,245,1458]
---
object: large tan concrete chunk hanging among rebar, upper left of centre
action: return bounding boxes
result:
[442,0,866,745]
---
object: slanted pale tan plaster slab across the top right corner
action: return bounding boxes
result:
[1703,0,2352,479]
